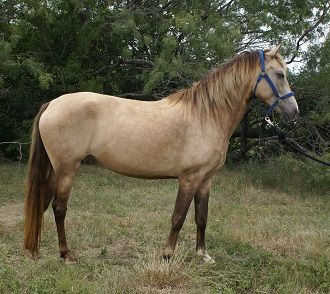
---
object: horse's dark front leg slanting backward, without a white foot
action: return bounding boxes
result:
[163,176,202,259]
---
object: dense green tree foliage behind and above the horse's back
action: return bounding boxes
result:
[0,0,330,158]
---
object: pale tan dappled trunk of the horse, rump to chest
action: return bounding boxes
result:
[39,92,232,178]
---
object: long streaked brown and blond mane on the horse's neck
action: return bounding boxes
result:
[165,50,285,122]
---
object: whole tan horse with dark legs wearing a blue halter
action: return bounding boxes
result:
[24,46,298,263]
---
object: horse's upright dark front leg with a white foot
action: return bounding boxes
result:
[194,180,214,263]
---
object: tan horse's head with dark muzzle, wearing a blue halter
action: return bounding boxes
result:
[254,45,299,121]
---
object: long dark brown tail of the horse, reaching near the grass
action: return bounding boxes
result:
[24,102,51,256]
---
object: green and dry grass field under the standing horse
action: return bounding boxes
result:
[0,165,330,293]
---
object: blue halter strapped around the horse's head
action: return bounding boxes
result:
[253,50,294,116]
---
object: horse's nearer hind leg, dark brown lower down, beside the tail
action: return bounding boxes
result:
[53,164,80,262]
